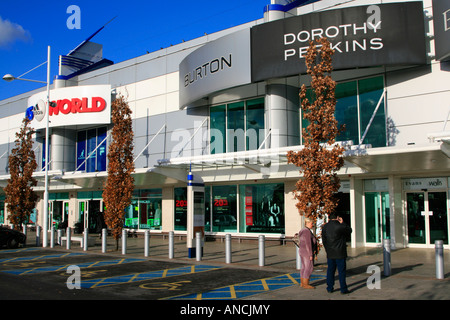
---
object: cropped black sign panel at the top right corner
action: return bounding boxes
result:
[433,0,450,61]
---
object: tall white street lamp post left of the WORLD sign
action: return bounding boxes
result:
[3,46,50,247]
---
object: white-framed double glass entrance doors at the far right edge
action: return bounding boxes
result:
[406,191,448,247]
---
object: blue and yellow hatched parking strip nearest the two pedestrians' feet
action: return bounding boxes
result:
[164,272,326,300]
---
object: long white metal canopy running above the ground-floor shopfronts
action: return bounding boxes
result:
[0,143,450,195]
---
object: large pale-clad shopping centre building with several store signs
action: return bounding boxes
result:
[0,0,450,248]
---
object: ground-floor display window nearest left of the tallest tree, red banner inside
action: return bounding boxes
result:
[239,183,285,233]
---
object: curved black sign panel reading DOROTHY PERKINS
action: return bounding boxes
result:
[251,2,427,82]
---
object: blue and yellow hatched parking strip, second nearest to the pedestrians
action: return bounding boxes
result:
[81,265,222,288]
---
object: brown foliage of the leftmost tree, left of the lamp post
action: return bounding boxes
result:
[4,118,38,230]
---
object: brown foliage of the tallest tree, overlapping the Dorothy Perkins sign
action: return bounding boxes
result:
[287,38,344,225]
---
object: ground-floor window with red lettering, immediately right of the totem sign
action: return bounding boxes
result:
[211,186,237,232]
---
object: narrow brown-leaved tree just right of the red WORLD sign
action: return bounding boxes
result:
[103,96,134,250]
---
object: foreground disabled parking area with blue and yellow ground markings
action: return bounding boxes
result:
[0,247,322,300]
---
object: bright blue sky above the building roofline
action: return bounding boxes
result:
[0,0,270,100]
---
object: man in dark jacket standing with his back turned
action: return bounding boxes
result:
[322,213,352,294]
